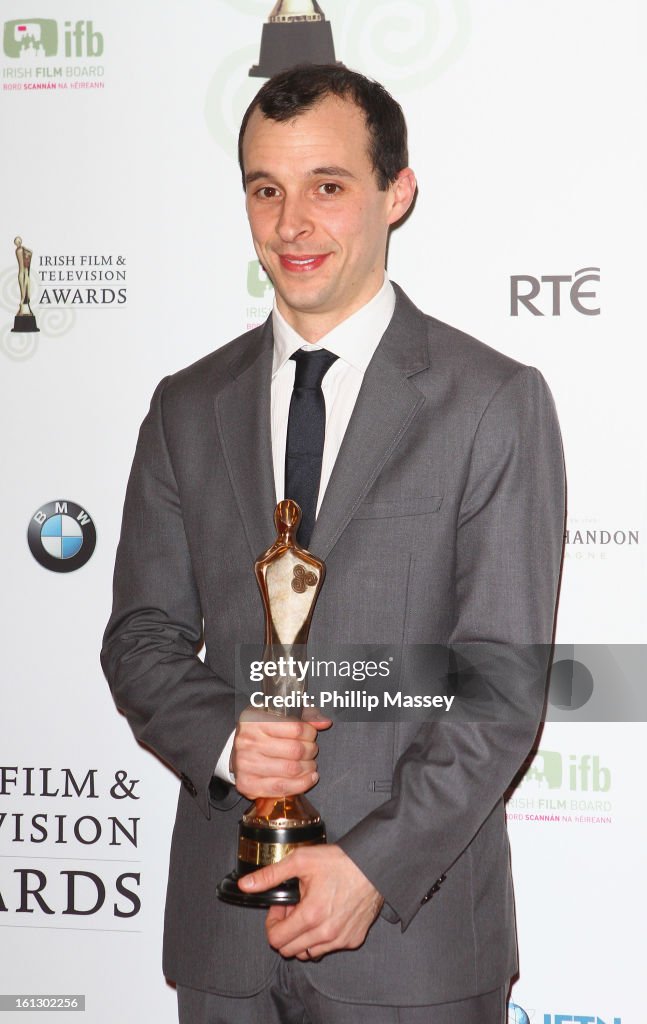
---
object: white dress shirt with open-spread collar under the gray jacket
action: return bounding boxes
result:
[215,275,395,782]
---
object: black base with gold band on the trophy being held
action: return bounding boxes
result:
[217,819,326,907]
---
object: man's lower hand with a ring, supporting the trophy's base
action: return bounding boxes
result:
[239,845,384,961]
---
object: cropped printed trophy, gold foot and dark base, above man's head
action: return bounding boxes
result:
[250,0,336,78]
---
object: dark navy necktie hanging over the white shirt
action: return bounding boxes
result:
[285,348,337,548]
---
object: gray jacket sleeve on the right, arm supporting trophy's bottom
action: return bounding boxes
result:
[339,367,565,929]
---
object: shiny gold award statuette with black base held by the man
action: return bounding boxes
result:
[218,499,326,907]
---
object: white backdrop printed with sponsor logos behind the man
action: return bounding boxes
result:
[0,0,647,1024]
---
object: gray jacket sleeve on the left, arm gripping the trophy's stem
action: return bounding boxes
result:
[101,380,241,817]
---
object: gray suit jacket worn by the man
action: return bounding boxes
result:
[102,289,564,1005]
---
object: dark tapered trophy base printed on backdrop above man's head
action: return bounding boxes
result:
[250,22,338,78]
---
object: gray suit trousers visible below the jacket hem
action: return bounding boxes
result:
[177,961,509,1024]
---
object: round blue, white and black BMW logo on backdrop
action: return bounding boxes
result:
[27,501,96,572]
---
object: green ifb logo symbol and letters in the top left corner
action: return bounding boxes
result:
[4,17,103,60]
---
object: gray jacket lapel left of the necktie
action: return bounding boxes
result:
[215,318,276,559]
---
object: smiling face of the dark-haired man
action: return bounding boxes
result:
[243,96,413,341]
